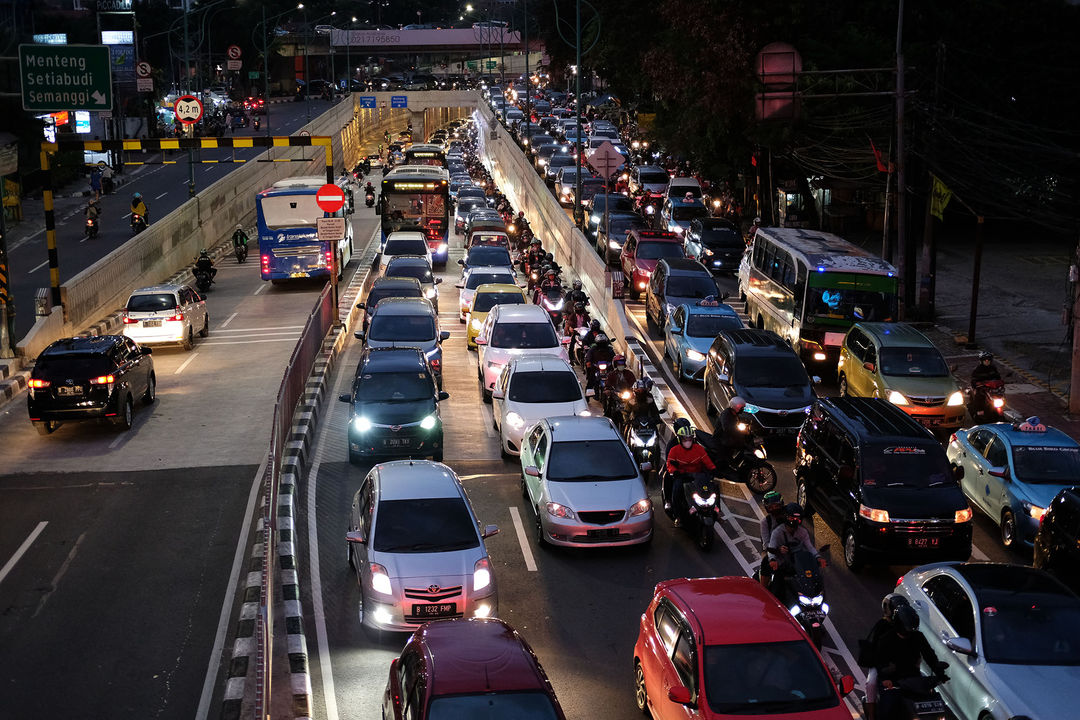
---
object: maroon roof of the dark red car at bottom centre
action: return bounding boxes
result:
[416,617,548,696]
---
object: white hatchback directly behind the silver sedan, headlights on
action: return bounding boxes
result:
[491,357,592,456]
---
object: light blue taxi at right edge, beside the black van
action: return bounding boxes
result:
[946,418,1080,547]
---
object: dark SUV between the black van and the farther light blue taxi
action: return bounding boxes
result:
[704,328,814,435]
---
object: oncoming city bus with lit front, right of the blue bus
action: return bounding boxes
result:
[375,165,450,268]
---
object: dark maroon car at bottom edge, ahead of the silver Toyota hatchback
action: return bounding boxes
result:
[382,617,566,720]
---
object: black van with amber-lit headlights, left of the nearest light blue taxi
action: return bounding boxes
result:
[795,397,971,571]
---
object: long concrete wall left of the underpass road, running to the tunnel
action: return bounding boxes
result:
[17,99,408,362]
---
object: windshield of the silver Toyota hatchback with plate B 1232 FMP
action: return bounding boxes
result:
[372,498,480,553]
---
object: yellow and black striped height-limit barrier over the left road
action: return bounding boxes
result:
[41,135,334,305]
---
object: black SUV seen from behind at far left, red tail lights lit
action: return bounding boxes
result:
[26,335,157,435]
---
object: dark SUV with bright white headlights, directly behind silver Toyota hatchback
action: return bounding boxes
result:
[338,348,450,463]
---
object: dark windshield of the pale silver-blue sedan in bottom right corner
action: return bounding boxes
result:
[978,588,1080,665]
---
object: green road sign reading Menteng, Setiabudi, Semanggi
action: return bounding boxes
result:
[18,44,112,112]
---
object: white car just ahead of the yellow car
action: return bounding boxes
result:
[476,305,570,403]
